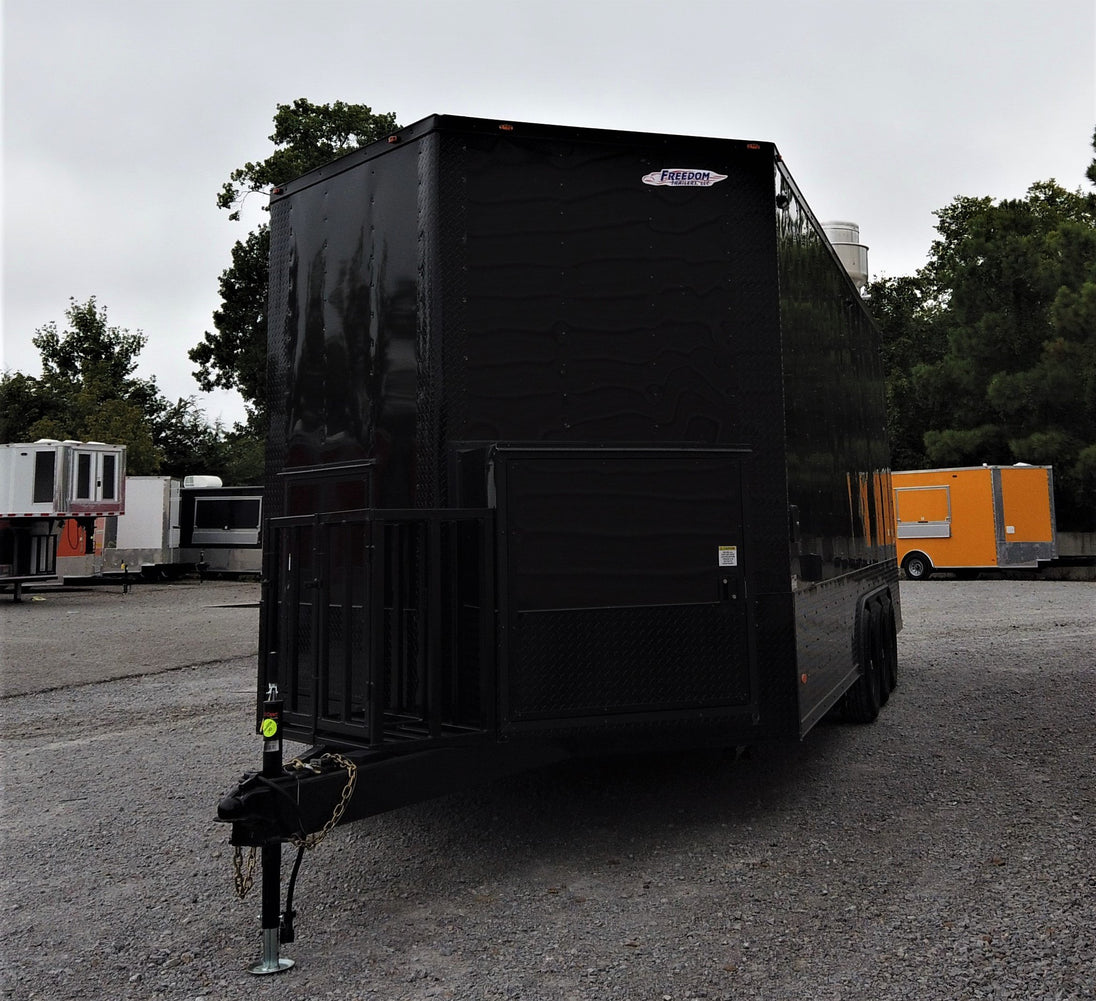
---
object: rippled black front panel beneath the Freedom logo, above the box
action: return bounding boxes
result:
[446,131,768,443]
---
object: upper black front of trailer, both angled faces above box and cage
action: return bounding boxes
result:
[271,118,787,546]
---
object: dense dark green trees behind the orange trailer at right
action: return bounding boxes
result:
[869,136,1096,531]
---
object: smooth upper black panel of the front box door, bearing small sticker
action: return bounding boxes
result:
[495,448,746,610]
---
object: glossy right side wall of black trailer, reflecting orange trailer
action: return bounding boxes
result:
[777,163,901,730]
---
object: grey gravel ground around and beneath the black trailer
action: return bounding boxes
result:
[0,581,1096,1001]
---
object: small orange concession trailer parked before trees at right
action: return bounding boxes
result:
[891,464,1058,580]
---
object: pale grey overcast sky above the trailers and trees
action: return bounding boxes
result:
[0,0,1096,423]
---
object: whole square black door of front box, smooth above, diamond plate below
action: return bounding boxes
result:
[493,446,757,730]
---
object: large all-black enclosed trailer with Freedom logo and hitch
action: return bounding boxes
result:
[219,116,901,969]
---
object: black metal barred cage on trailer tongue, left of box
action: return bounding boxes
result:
[264,509,494,747]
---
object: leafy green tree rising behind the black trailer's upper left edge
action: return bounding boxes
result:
[189,98,399,418]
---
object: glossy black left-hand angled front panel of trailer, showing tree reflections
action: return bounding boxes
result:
[270,140,421,504]
